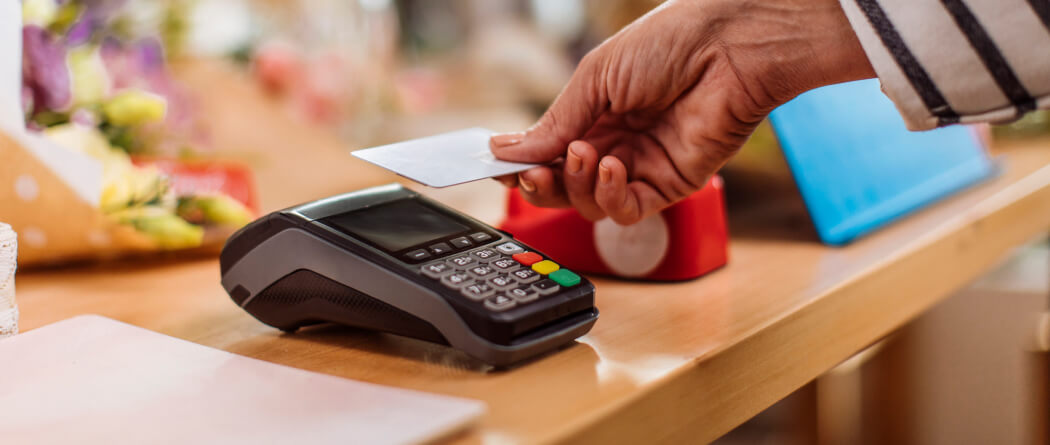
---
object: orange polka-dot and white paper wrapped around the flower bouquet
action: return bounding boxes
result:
[0,2,150,265]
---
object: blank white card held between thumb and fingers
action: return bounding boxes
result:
[353,128,538,188]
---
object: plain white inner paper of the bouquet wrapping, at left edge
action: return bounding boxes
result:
[0,6,102,207]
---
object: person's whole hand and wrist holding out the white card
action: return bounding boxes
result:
[490,0,875,225]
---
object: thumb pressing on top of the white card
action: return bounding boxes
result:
[488,54,608,163]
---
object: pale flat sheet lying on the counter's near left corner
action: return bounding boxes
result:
[0,314,485,445]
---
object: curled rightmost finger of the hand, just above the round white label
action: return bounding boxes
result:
[594,156,671,226]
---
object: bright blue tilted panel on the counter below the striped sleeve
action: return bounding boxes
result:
[770,80,995,245]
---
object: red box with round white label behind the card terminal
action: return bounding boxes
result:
[500,176,729,281]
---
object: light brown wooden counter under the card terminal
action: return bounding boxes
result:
[18,63,1050,444]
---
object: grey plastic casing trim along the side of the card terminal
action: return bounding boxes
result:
[222,186,597,366]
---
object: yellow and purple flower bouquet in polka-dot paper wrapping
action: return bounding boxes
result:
[0,0,254,266]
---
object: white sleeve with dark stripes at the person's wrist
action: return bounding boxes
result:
[840,0,1050,130]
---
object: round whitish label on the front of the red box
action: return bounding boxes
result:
[594,213,671,277]
